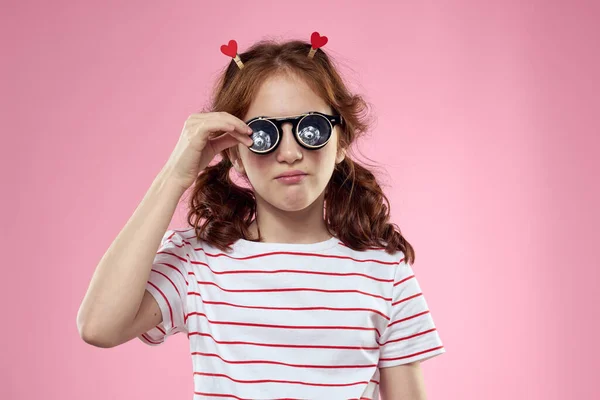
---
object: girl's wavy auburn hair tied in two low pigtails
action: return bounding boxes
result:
[187,36,415,264]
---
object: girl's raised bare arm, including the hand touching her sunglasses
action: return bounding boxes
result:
[77,112,252,347]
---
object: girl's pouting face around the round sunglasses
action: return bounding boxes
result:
[232,75,345,211]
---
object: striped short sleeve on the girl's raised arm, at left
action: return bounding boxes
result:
[138,230,190,346]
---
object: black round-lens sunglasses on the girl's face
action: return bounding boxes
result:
[241,111,342,154]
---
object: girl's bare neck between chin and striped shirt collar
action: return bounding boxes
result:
[250,191,331,244]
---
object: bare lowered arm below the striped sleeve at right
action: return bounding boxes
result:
[379,361,427,400]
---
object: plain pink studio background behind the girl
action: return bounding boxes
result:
[0,0,600,400]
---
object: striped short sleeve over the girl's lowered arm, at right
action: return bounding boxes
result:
[378,255,446,368]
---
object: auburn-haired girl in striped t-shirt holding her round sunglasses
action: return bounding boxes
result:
[77,32,445,400]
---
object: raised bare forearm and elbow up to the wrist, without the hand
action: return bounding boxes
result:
[77,166,185,347]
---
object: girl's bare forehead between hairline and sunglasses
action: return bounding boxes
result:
[244,74,331,121]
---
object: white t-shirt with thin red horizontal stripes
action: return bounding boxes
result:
[139,228,445,400]
